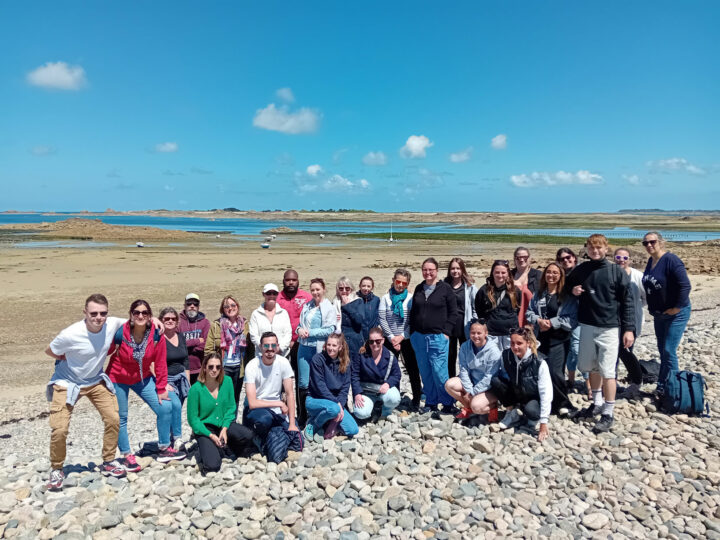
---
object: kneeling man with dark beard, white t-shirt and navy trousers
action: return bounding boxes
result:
[243,332,302,463]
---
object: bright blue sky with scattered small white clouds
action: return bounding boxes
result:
[0,1,720,212]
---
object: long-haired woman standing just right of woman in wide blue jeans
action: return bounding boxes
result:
[445,257,477,378]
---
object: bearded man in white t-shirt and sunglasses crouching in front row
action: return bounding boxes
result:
[243,332,298,445]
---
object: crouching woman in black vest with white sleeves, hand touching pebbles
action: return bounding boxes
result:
[490,326,553,441]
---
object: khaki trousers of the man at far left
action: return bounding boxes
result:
[50,382,120,469]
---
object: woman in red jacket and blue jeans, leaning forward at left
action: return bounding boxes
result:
[107,300,185,472]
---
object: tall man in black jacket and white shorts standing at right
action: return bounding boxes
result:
[565,234,635,433]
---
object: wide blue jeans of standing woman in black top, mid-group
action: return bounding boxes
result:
[410,332,455,406]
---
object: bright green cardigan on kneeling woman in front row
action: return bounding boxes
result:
[187,377,236,437]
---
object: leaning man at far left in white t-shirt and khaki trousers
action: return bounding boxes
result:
[45,294,125,491]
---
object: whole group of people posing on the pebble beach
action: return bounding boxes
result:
[46,232,690,490]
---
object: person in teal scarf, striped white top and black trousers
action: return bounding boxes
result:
[378,268,422,410]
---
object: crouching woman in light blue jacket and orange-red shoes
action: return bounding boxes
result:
[445,322,502,422]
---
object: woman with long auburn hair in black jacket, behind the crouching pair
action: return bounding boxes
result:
[475,259,521,351]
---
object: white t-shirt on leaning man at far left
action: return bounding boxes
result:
[50,317,125,388]
